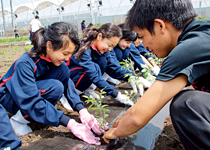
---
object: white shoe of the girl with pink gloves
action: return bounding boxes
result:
[10,110,32,136]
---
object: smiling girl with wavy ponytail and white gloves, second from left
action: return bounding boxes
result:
[66,23,138,105]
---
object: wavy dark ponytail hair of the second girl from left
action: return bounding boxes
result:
[75,23,122,59]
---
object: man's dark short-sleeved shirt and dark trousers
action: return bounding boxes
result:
[156,20,210,150]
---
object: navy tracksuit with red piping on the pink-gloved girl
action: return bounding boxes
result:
[0,52,84,149]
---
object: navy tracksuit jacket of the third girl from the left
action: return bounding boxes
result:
[113,43,145,70]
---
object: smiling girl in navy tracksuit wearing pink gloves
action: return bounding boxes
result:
[0,22,100,149]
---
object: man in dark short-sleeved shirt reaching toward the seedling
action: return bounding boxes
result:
[104,0,210,150]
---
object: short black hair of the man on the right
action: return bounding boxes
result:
[126,0,197,34]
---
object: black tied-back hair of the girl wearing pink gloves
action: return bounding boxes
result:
[28,22,80,57]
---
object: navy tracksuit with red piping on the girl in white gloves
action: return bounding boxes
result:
[66,44,133,98]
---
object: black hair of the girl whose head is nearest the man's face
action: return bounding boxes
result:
[118,23,137,41]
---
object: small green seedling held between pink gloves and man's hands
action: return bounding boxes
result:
[83,89,110,129]
